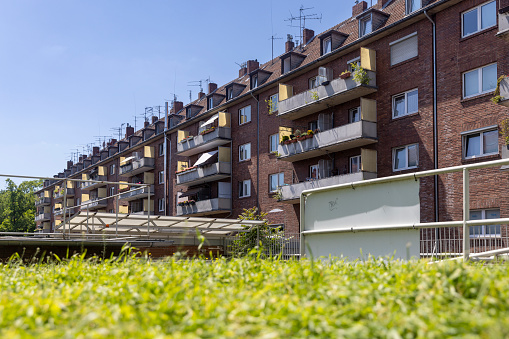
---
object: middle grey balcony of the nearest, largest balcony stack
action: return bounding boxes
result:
[278,120,377,162]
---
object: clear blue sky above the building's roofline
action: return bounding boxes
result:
[0,0,354,189]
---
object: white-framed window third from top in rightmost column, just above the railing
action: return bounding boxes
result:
[463,129,498,159]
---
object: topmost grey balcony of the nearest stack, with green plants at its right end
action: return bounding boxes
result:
[278,71,377,120]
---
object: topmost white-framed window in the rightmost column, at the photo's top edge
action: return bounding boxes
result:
[461,1,497,37]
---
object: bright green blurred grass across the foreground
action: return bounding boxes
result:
[0,257,509,339]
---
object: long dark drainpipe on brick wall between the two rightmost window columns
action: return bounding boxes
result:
[424,11,440,253]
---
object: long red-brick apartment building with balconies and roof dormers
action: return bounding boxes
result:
[36,0,509,247]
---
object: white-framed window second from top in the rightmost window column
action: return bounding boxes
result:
[463,64,497,98]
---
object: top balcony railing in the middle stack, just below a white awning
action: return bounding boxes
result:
[177,127,231,157]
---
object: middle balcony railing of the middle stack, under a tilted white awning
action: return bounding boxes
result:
[177,161,232,186]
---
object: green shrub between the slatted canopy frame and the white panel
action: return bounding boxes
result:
[231,207,283,257]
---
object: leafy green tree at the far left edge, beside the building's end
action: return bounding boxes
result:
[0,179,42,232]
